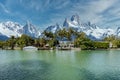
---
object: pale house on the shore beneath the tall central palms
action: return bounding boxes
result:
[58,41,74,50]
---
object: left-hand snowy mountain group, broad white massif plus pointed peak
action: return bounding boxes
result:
[0,21,40,40]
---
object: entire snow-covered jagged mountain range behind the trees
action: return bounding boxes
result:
[0,15,120,40]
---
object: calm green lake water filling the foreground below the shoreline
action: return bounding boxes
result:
[0,50,120,80]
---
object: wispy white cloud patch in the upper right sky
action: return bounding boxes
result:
[80,0,117,23]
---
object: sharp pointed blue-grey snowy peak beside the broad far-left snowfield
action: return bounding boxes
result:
[23,21,41,37]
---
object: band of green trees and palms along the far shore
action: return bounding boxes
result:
[0,28,120,50]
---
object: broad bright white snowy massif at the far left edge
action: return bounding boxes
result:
[0,21,22,37]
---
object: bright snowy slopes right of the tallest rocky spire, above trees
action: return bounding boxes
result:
[80,22,115,40]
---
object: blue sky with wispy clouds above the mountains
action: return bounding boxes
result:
[0,0,120,29]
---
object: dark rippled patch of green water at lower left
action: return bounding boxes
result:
[0,60,50,80]
